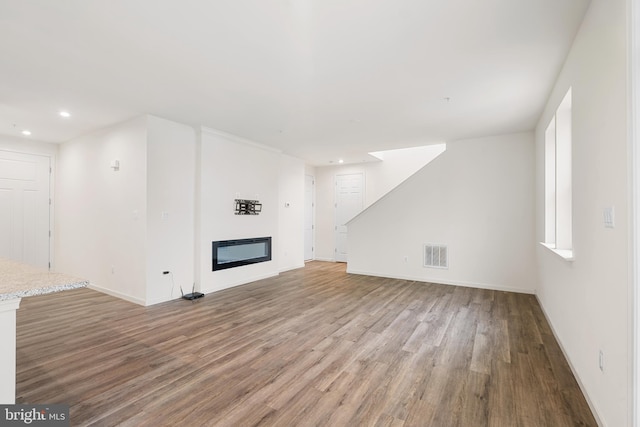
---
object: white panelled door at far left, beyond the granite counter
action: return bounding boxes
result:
[0,150,50,268]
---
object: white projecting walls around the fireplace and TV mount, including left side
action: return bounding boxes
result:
[56,116,305,305]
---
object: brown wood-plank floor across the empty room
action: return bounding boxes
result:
[17,262,596,427]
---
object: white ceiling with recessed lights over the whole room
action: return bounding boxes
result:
[0,0,589,165]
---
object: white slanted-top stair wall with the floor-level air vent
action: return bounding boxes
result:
[347,133,536,293]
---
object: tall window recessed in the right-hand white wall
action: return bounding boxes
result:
[544,89,573,259]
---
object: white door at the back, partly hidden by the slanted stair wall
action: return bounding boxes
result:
[335,173,364,262]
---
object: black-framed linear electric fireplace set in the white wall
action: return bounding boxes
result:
[212,237,271,271]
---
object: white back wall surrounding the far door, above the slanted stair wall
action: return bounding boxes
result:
[315,144,444,261]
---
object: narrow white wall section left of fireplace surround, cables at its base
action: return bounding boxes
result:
[146,116,196,304]
